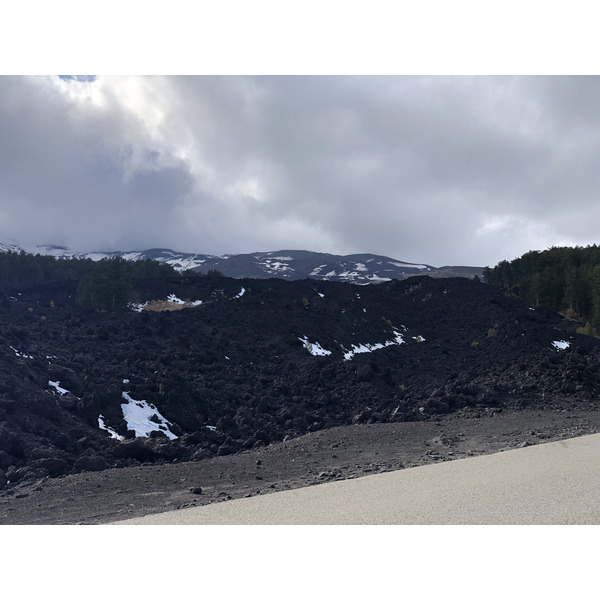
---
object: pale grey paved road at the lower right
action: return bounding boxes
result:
[115,434,600,525]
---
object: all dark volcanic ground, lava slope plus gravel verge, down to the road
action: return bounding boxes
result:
[0,277,600,523]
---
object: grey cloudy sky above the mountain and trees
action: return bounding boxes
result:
[0,75,600,266]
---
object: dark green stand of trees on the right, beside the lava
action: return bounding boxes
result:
[482,244,600,326]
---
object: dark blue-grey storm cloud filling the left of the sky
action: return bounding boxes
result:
[0,77,192,250]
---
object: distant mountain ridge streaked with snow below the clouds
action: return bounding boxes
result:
[0,243,482,284]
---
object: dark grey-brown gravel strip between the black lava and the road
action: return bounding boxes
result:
[0,409,600,525]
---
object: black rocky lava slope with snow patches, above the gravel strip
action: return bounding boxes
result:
[0,276,600,487]
